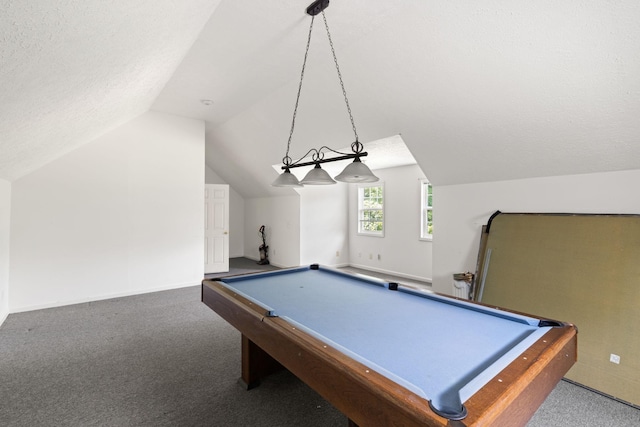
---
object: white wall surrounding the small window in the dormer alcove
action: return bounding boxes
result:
[349,165,437,281]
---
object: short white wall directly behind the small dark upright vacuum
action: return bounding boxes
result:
[244,195,300,267]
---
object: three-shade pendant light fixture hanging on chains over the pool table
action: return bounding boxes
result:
[271,0,378,187]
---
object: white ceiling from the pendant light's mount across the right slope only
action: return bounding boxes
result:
[153,0,640,197]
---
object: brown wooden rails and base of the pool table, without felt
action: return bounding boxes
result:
[202,280,577,427]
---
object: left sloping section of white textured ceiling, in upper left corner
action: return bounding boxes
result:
[0,0,219,180]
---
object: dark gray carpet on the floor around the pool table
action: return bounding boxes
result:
[0,260,640,427]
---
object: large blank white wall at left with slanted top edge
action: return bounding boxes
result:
[9,112,205,312]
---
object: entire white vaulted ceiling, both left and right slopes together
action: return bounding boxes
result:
[0,0,640,197]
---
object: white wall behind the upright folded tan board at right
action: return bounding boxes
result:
[433,170,640,293]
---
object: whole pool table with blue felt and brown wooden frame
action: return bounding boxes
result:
[202,264,577,427]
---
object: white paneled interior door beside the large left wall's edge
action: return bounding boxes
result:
[204,184,229,273]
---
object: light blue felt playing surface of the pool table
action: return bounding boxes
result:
[224,268,548,411]
